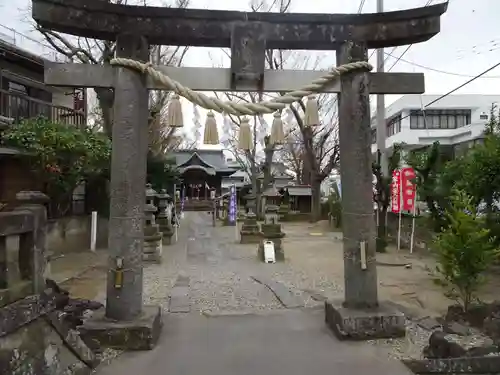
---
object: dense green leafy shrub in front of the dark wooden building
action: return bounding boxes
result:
[2,117,111,217]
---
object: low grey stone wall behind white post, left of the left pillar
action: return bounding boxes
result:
[47,215,109,255]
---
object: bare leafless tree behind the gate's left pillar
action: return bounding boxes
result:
[35,0,189,153]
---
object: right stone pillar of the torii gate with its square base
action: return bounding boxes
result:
[325,42,406,340]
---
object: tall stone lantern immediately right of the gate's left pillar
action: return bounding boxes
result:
[143,184,162,263]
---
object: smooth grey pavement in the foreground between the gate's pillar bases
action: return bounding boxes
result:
[97,309,411,375]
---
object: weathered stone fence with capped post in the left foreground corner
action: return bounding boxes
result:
[0,192,95,375]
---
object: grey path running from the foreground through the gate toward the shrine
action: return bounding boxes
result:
[98,213,410,375]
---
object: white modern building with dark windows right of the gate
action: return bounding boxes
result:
[371,95,500,159]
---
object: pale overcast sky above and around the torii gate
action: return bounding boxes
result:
[0,0,500,148]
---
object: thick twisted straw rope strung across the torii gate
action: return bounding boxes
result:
[110,58,373,116]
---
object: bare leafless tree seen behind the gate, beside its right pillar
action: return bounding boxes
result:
[217,0,339,221]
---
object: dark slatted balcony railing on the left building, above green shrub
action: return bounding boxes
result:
[0,90,86,126]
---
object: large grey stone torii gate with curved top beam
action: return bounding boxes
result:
[32,0,447,349]
